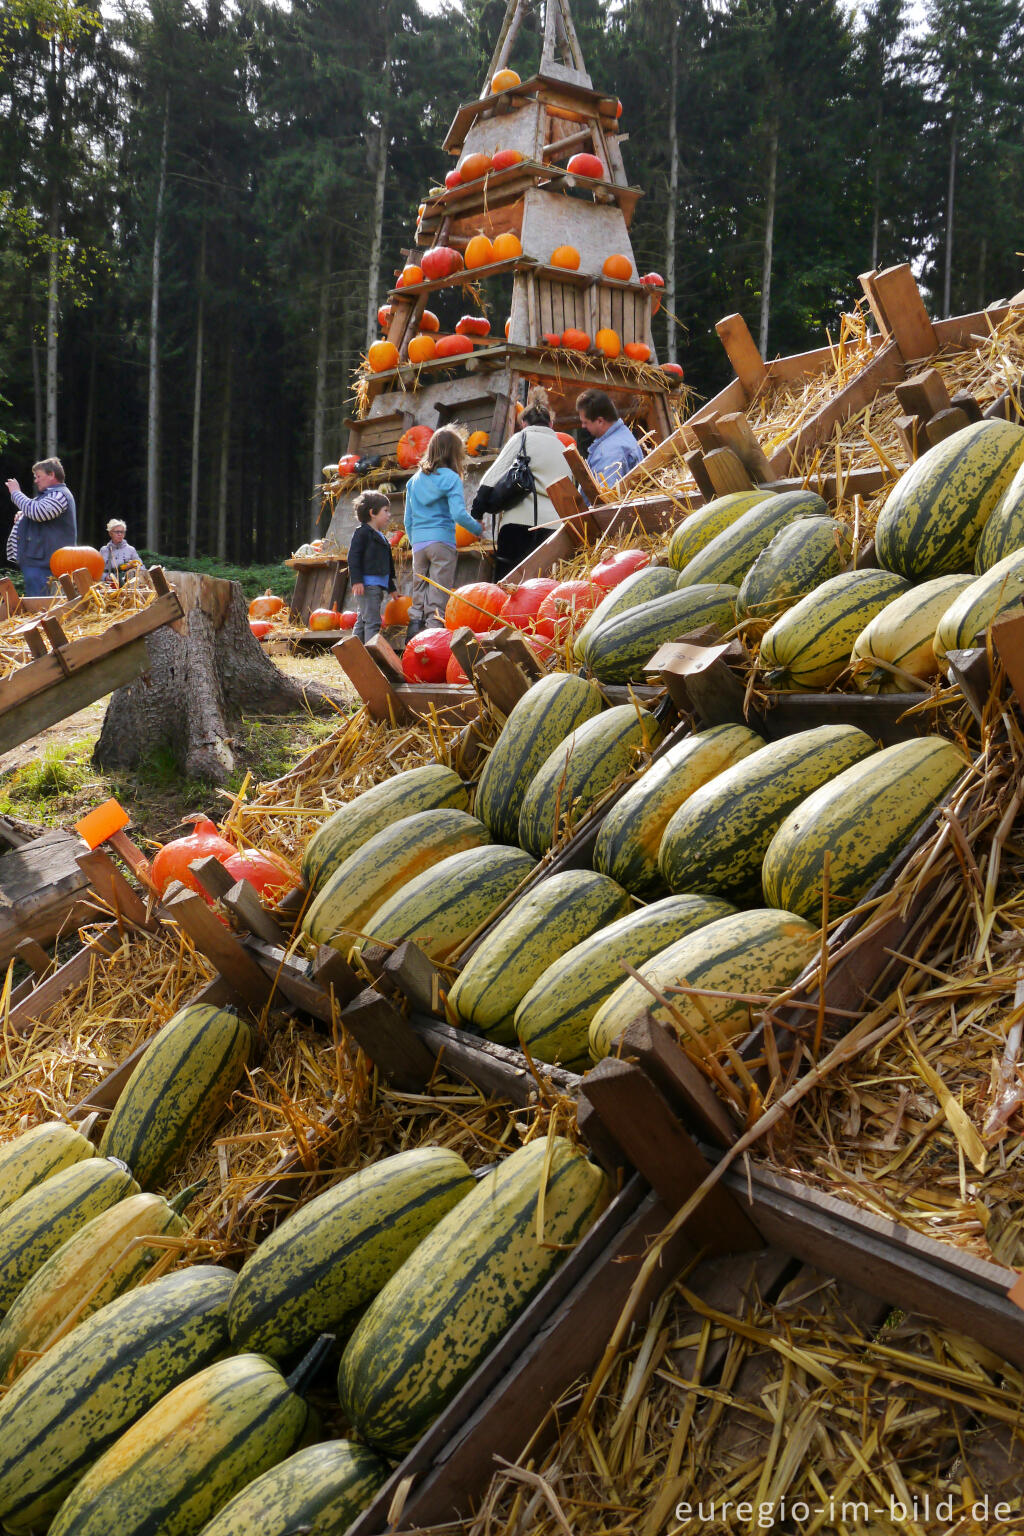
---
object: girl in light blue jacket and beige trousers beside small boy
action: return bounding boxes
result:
[405,427,484,639]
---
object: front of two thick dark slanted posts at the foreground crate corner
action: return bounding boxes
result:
[580,1058,761,1253]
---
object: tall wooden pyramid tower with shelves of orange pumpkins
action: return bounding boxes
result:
[330,0,679,544]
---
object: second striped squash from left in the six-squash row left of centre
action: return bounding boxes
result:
[302,809,491,954]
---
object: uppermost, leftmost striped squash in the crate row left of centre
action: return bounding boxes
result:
[302,763,470,891]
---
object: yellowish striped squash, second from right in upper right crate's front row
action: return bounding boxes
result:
[851,576,973,693]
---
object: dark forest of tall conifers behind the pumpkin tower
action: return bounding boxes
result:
[0,0,1024,564]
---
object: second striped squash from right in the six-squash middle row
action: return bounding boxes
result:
[516,895,734,1069]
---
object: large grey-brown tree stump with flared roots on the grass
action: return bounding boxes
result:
[92,570,350,783]
